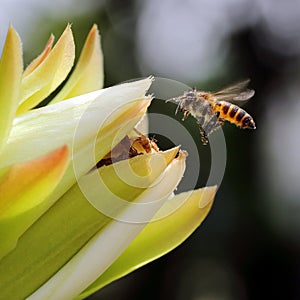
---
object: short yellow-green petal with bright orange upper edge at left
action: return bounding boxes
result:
[0,146,68,259]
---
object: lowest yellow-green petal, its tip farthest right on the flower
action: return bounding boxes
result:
[76,187,216,299]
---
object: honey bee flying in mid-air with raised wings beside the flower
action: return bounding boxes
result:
[166,80,255,145]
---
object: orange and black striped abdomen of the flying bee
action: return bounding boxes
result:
[213,101,255,129]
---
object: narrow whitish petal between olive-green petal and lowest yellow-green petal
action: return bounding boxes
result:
[28,151,185,300]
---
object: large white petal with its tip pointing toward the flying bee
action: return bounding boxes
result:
[0,78,152,168]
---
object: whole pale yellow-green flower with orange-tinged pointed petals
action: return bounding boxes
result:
[0,25,215,299]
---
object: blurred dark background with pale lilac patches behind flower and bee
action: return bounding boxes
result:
[0,0,300,300]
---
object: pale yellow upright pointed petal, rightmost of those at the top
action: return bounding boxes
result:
[51,25,104,103]
